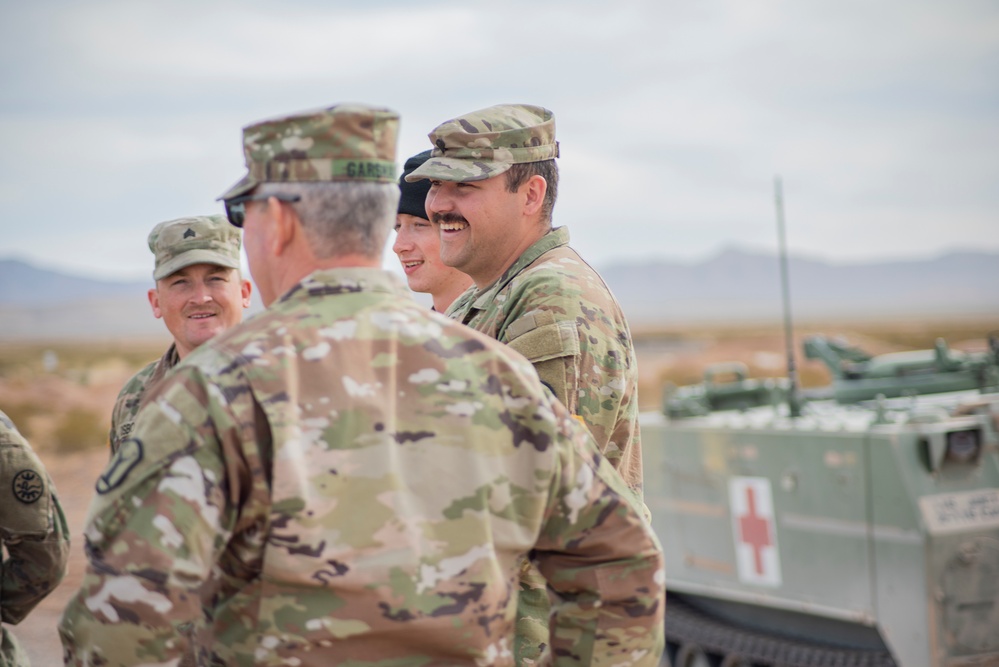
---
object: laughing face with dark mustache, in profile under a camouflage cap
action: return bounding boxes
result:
[427,174,544,288]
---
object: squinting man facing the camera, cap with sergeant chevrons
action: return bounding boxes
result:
[110,215,252,454]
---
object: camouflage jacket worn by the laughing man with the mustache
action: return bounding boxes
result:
[447,227,642,496]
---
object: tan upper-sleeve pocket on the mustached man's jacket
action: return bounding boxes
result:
[506,311,579,413]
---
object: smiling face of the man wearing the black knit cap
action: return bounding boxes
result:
[392,213,468,295]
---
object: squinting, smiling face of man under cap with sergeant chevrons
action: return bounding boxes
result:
[149,264,251,358]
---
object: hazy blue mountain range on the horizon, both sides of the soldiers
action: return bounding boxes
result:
[0,249,999,340]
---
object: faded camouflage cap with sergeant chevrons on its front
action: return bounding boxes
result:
[149,215,240,280]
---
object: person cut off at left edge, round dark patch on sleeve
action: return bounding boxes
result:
[0,412,69,667]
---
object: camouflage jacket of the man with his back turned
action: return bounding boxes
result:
[60,269,665,667]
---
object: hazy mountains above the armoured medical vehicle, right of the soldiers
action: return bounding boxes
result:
[601,249,999,324]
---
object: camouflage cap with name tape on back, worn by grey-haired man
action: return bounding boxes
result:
[219,104,399,199]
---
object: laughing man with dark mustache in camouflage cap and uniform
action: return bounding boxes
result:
[406,105,642,661]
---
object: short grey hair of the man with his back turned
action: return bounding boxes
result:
[257,181,399,259]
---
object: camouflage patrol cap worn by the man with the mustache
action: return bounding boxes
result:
[406,104,558,182]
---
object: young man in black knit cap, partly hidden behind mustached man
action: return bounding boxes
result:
[392,151,472,313]
